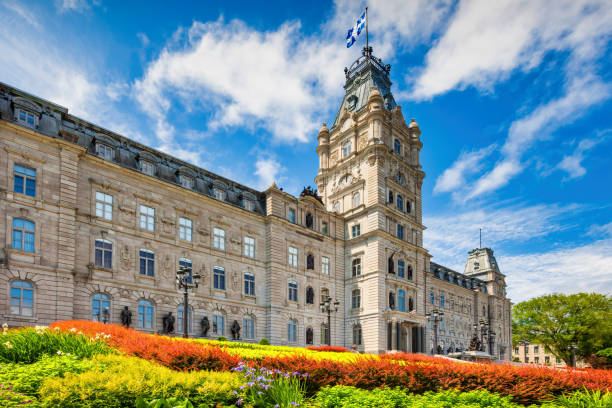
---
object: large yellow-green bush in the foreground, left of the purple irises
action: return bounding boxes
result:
[40,355,244,408]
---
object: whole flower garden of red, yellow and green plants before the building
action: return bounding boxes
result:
[0,321,612,408]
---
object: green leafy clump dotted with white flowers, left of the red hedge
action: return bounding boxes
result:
[0,327,112,364]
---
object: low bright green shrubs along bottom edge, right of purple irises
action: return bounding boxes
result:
[315,386,521,408]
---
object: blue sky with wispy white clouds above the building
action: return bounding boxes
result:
[0,0,612,303]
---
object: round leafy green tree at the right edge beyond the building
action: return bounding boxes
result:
[512,293,612,366]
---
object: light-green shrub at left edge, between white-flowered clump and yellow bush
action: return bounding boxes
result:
[0,355,92,396]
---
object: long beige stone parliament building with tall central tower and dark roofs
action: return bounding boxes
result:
[0,48,512,360]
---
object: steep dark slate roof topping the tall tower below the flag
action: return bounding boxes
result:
[332,46,397,128]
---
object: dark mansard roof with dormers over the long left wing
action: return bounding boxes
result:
[0,82,266,214]
